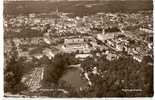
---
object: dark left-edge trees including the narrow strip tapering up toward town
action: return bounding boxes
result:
[4,41,26,94]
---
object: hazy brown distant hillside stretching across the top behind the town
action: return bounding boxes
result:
[4,0,153,16]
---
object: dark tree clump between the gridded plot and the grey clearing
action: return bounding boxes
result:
[44,54,77,85]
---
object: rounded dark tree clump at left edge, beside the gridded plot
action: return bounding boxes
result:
[4,58,26,94]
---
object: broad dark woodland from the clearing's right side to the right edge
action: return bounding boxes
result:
[82,56,153,97]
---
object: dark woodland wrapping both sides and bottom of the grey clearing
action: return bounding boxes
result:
[39,54,153,97]
